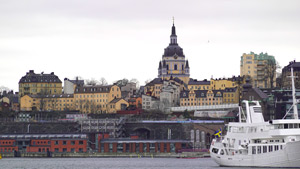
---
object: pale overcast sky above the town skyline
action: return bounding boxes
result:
[0,0,300,91]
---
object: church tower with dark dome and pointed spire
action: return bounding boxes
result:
[158,21,190,84]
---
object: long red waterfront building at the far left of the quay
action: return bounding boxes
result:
[0,134,88,153]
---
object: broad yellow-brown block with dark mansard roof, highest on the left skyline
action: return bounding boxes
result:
[19,70,62,97]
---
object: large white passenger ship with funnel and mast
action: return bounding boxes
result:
[210,68,300,168]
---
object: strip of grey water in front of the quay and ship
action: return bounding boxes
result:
[0,158,282,169]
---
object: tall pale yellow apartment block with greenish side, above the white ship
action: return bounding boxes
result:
[240,52,276,88]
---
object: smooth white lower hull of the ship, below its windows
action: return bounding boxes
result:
[211,141,300,168]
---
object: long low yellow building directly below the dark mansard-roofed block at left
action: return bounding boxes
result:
[20,94,75,111]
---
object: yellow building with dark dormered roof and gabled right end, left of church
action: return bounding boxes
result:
[74,85,121,113]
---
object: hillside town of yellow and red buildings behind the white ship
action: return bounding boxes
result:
[0,23,300,157]
